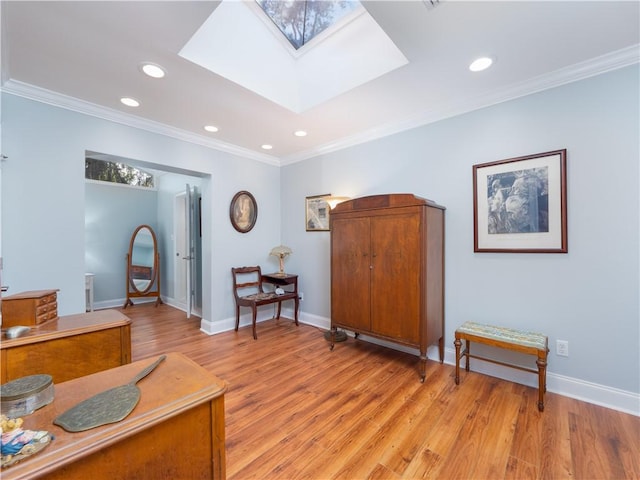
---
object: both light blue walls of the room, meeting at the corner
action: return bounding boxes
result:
[1,66,640,395]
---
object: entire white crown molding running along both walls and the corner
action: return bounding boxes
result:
[0,44,640,166]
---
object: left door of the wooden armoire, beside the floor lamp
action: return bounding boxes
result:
[331,217,371,331]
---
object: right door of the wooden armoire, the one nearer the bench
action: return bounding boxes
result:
[371,210,424,345]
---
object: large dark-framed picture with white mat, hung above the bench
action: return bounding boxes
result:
[473,149,567,253]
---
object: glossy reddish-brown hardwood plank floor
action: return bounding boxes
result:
[124,304,640,480]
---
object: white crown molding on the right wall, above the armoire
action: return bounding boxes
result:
[280,44,640,165]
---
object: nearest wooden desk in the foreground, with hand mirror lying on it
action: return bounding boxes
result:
[2,353,226,480]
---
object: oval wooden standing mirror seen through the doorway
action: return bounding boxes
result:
[124,225,162,308]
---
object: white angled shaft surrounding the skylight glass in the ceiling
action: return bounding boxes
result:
[180,0,408,113]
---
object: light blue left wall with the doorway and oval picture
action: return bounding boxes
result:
[1,93,281,323]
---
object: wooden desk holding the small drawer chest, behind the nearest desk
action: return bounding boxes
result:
[0,310,131,384]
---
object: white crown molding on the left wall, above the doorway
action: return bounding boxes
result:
[0,80,280,166]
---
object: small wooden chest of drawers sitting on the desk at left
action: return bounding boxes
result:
[2,290,58,328]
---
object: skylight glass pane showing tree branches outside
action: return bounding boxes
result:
[256,0,360,50]
